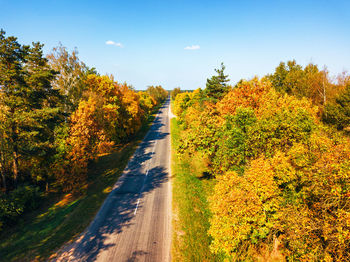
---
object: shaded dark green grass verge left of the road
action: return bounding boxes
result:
[0,108,159,261]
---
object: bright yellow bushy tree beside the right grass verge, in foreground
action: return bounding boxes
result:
[209,158,280,259]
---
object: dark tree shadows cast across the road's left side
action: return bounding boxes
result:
[53,103,169,261]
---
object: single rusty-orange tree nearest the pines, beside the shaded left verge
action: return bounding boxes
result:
[56,95,114,193]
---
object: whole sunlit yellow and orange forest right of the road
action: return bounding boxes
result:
[172,60,350,261]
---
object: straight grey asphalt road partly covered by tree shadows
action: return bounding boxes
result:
[54,100,171,262]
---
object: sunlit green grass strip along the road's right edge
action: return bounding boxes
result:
[171,118,221,261]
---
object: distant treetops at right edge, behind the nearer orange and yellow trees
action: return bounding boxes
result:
[267,60,350,130]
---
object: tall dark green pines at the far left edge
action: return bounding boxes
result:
[0,30,63,185]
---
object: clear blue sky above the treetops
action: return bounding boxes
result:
[0,0,350,89]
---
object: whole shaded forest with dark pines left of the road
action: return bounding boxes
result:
[0,30,168,231]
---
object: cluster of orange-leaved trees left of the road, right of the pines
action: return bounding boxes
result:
[58,75,152,190]
